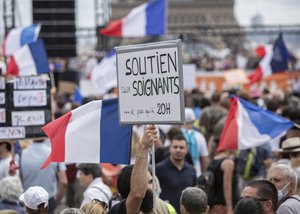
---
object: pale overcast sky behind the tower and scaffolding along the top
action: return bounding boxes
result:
[16,0,300,27]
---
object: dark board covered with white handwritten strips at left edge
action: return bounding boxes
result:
[0,76,51,140]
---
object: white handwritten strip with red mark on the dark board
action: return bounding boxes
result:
[14,90,47,107]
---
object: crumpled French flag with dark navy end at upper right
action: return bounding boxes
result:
[249,33,290,84]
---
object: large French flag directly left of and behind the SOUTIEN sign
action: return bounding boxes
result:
[41,99,131,169]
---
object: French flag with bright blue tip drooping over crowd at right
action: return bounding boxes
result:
[217,97,294,152]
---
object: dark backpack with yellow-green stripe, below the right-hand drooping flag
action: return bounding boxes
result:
[237,147,260,180]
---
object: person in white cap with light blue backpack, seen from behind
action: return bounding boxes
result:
[181,108,208,177]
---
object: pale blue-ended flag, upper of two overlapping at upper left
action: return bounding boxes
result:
[2,25,41,56]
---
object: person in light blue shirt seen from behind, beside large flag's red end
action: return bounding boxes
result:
[19,139,68,214]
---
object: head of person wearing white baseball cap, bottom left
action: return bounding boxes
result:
[20,186,49,214]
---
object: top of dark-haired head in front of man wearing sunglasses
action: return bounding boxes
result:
[234,197,264,214]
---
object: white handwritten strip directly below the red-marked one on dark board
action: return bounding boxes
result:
[11,111,45,126]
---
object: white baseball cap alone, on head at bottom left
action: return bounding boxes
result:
[19,186,49,210]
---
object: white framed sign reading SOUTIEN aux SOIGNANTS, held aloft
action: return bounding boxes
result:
[116,40,184,124]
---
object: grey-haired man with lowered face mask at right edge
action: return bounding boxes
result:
[268,164,300,214]
